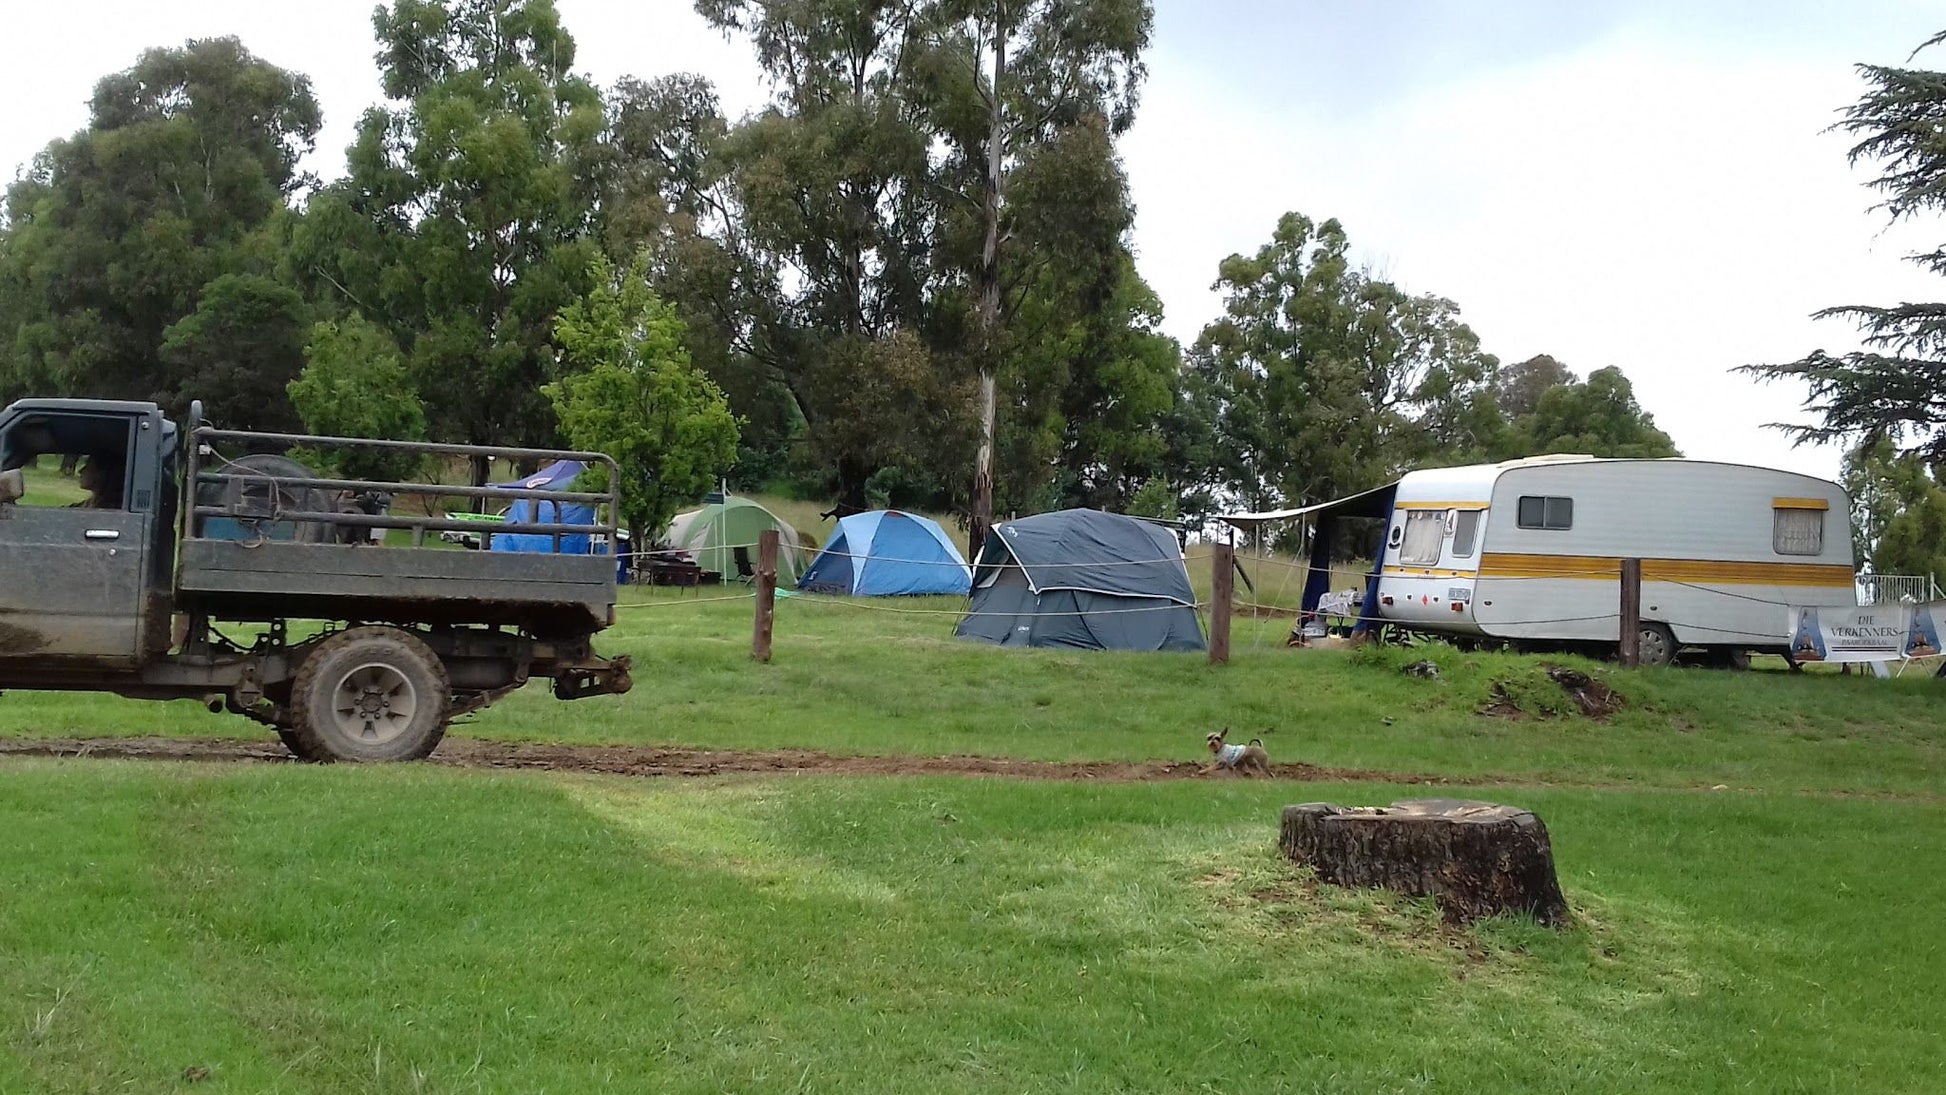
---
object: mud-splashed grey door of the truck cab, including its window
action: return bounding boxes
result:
[0,410,154,665]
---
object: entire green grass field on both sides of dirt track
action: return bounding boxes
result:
[0,525,1946,1091]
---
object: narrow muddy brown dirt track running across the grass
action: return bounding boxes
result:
[0,737,1479,784]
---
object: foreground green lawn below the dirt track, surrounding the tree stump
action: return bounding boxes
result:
[0,762,1946,1091]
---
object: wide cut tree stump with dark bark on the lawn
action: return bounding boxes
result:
[1280,799,1568,928]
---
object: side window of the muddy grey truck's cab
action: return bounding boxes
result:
[0,414,134,510]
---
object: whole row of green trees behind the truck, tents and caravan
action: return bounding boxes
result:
[0,0,1704,537]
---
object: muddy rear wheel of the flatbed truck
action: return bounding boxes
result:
[290,628,451,760]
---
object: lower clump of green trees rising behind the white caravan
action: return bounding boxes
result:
[1164,212,1677,525]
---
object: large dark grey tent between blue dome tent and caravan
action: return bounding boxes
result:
[954,510,1205,650]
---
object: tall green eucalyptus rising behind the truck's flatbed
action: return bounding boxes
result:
[294,0,603,482]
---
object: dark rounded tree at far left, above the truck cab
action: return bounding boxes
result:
[0,39,321,412]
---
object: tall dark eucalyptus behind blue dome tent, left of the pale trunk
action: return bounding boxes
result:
[697,0,961,506]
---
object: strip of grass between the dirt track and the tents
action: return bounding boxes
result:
[0,587,1946,794]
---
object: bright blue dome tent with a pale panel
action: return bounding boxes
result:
[798,510,973,597]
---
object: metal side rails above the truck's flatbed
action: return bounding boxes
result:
[183,422,621,552]
